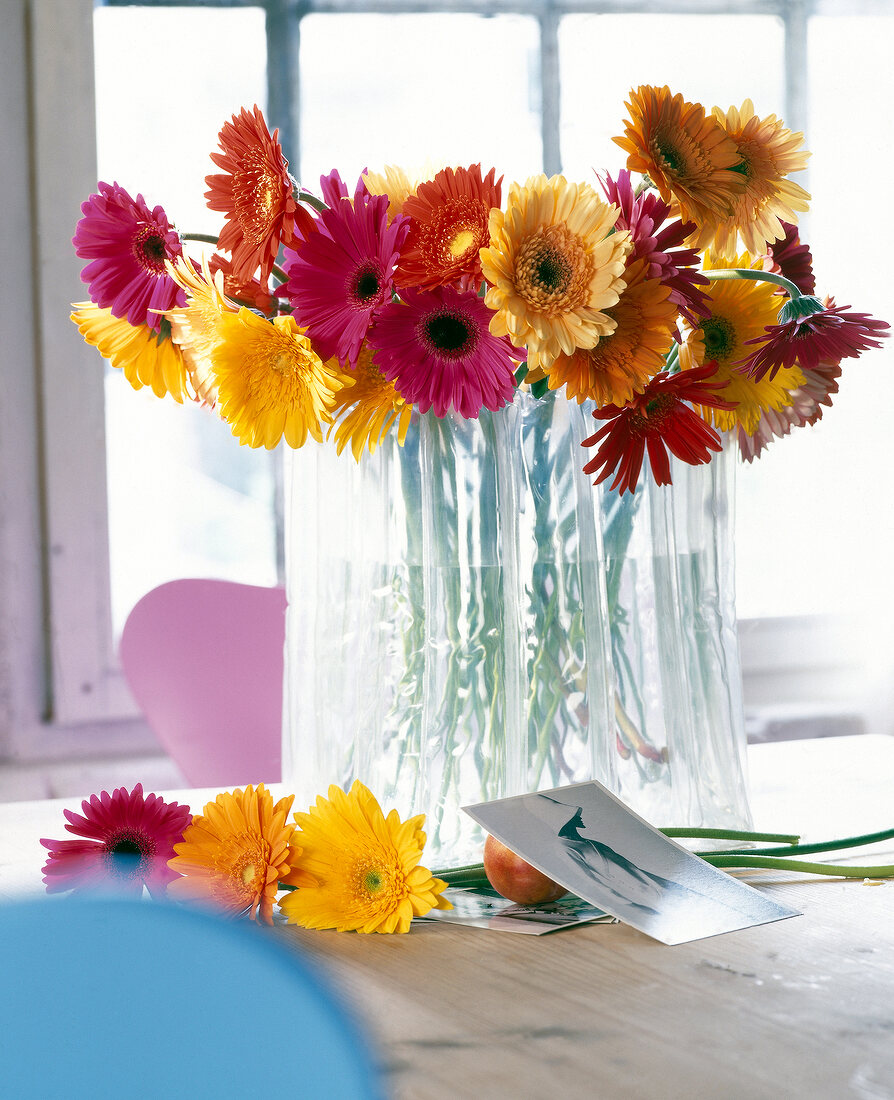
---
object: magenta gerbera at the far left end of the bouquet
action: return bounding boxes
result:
[71,183,186,330]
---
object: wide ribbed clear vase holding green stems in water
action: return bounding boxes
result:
[283,393,749,867]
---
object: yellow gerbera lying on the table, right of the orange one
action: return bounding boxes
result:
[279,782,451,932]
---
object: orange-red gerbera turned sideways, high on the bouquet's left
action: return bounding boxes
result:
[205,105,310,285]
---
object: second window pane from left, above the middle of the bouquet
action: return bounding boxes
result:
[301,14,541,190]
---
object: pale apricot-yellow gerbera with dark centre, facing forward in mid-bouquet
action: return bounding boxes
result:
[481,175,630,369]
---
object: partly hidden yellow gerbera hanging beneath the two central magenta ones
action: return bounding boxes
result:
[329,343,412,462]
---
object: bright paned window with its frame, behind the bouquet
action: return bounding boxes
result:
[0,0,894,774]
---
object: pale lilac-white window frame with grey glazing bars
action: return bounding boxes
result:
[0,0,879,760]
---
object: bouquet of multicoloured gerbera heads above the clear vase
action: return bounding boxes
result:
[73,86,887,492]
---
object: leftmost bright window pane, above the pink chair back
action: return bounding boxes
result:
[95,8,276,630]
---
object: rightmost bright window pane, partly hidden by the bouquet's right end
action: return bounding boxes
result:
[738,17,894,624]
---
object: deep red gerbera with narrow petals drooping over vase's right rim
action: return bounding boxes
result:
[581,363,732,493]
